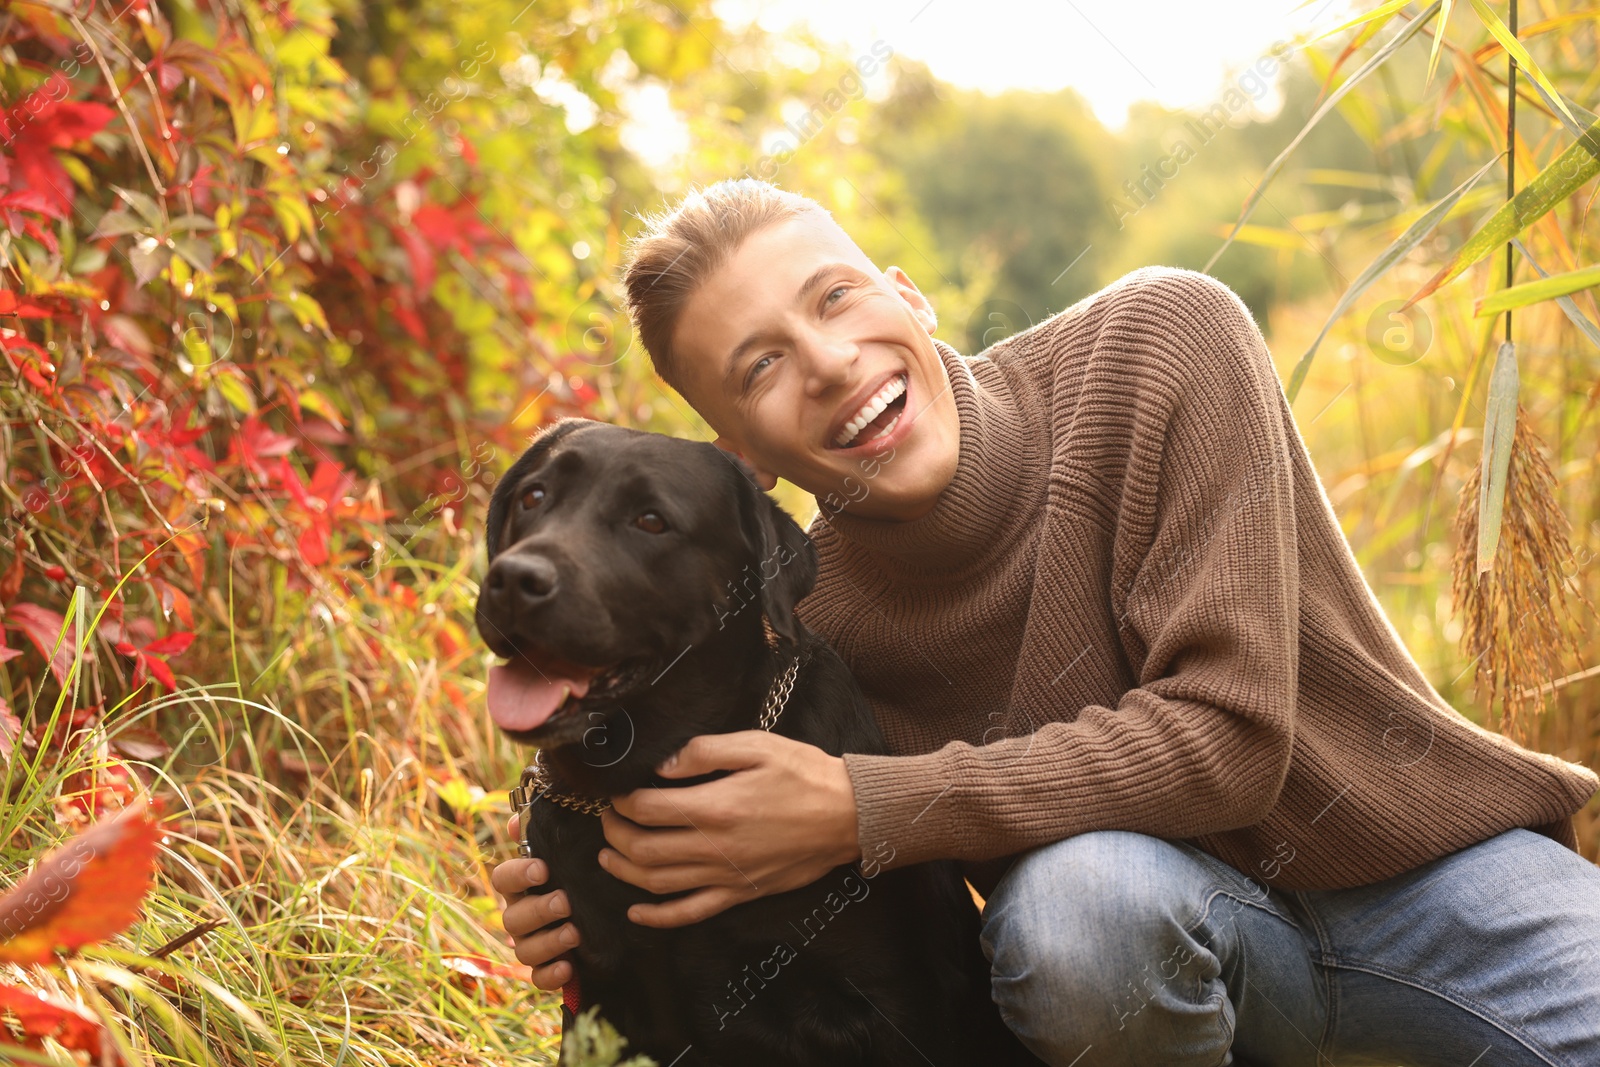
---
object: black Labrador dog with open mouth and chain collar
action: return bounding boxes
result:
[475,419,1038,1067]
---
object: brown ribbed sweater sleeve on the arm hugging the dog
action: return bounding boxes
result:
[845,270,1299,867]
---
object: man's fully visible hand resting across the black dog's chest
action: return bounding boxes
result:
[598,729,861,927]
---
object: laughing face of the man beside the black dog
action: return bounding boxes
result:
[674,213,960,522]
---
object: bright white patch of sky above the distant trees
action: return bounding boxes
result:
[715,0,1370,130]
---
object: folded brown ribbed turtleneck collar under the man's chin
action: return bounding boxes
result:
[812,339,1048,576]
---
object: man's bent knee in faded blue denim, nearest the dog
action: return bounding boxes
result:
[982,830,1234,1065]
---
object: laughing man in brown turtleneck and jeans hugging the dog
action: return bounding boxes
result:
[494,181,1600,1067]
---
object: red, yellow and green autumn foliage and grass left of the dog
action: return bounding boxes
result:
[0,0,715,1064]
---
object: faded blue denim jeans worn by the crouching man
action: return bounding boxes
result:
[982,830,1600,1067]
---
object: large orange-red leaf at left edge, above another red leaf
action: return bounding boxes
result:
[0,805,162,963]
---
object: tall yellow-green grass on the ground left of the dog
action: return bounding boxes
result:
[0,511,665,1067]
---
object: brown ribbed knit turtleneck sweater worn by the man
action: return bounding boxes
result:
[800,267,1597,893]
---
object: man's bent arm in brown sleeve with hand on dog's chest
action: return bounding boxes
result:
[605,268,1299,926]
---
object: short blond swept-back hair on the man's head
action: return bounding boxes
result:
[622,178,832,392]
